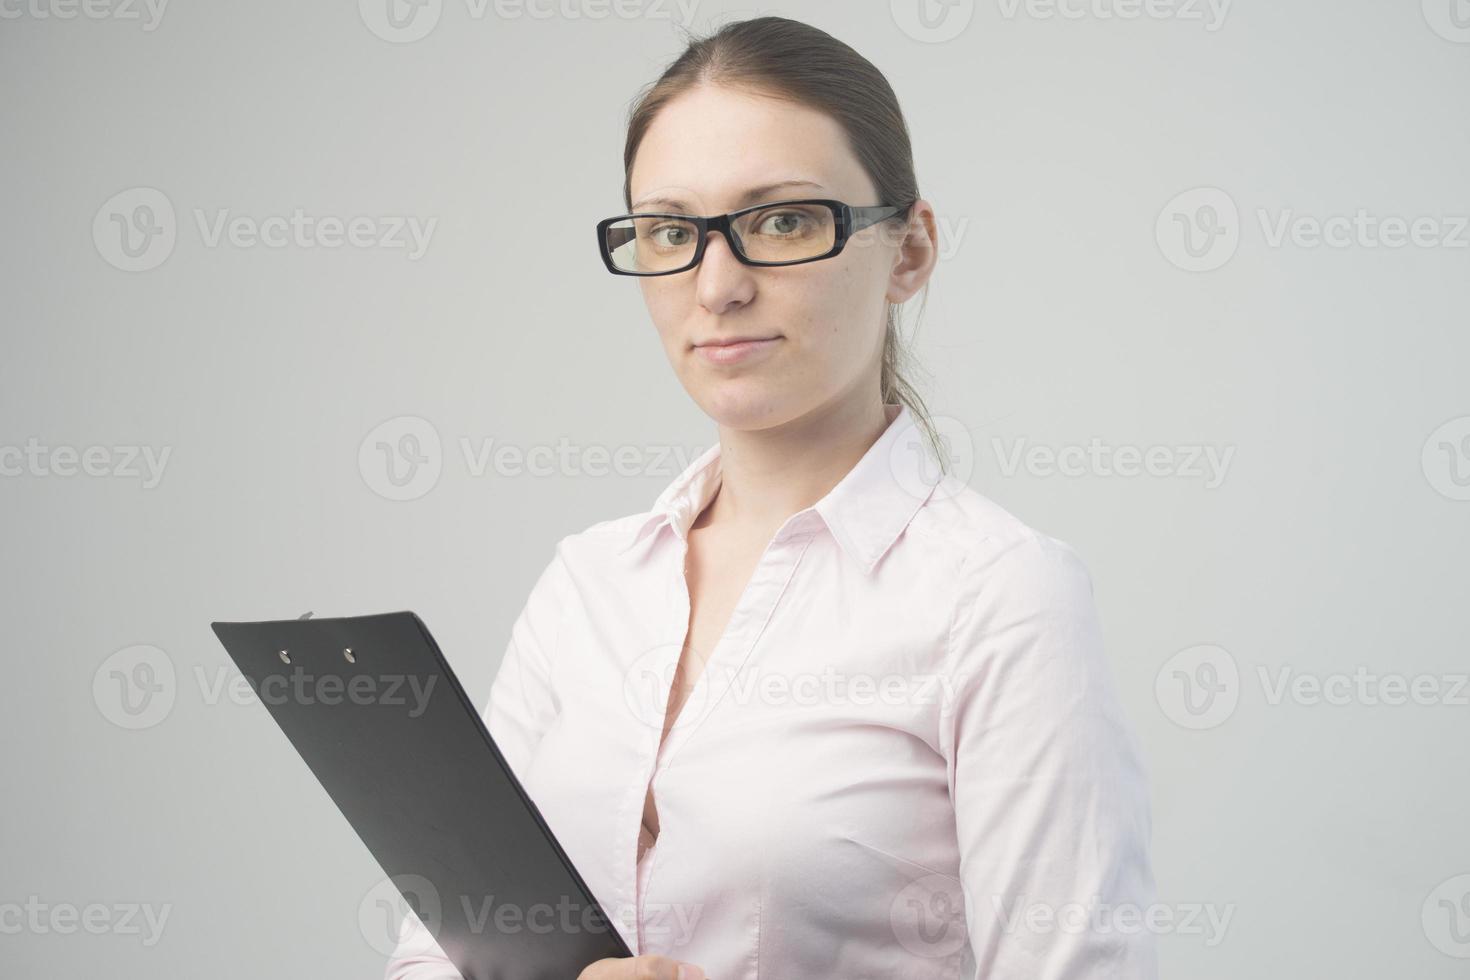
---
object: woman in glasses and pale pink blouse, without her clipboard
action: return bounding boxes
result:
[388,18,1155,980]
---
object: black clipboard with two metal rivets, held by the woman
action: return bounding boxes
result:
[210,611,632,980]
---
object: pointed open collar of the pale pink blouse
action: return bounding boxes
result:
[619,404,939,572]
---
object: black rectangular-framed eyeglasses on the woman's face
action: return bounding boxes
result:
[597,197,913,276]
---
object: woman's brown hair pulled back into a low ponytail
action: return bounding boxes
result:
[623,16,948,472]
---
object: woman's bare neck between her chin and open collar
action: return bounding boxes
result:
[695,398,889,533]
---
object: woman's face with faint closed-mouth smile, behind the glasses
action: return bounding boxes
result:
[629,84,932,429]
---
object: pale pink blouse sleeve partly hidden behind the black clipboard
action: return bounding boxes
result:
[384,539,567,980]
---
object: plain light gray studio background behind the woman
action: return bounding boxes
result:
[0,0,1470,980]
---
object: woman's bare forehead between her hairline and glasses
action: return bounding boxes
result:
[629,84,875,213]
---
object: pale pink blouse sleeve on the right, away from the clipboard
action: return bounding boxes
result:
[941,529,1157,980]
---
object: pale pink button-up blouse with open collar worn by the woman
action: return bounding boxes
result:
[385,406,1157,980]
